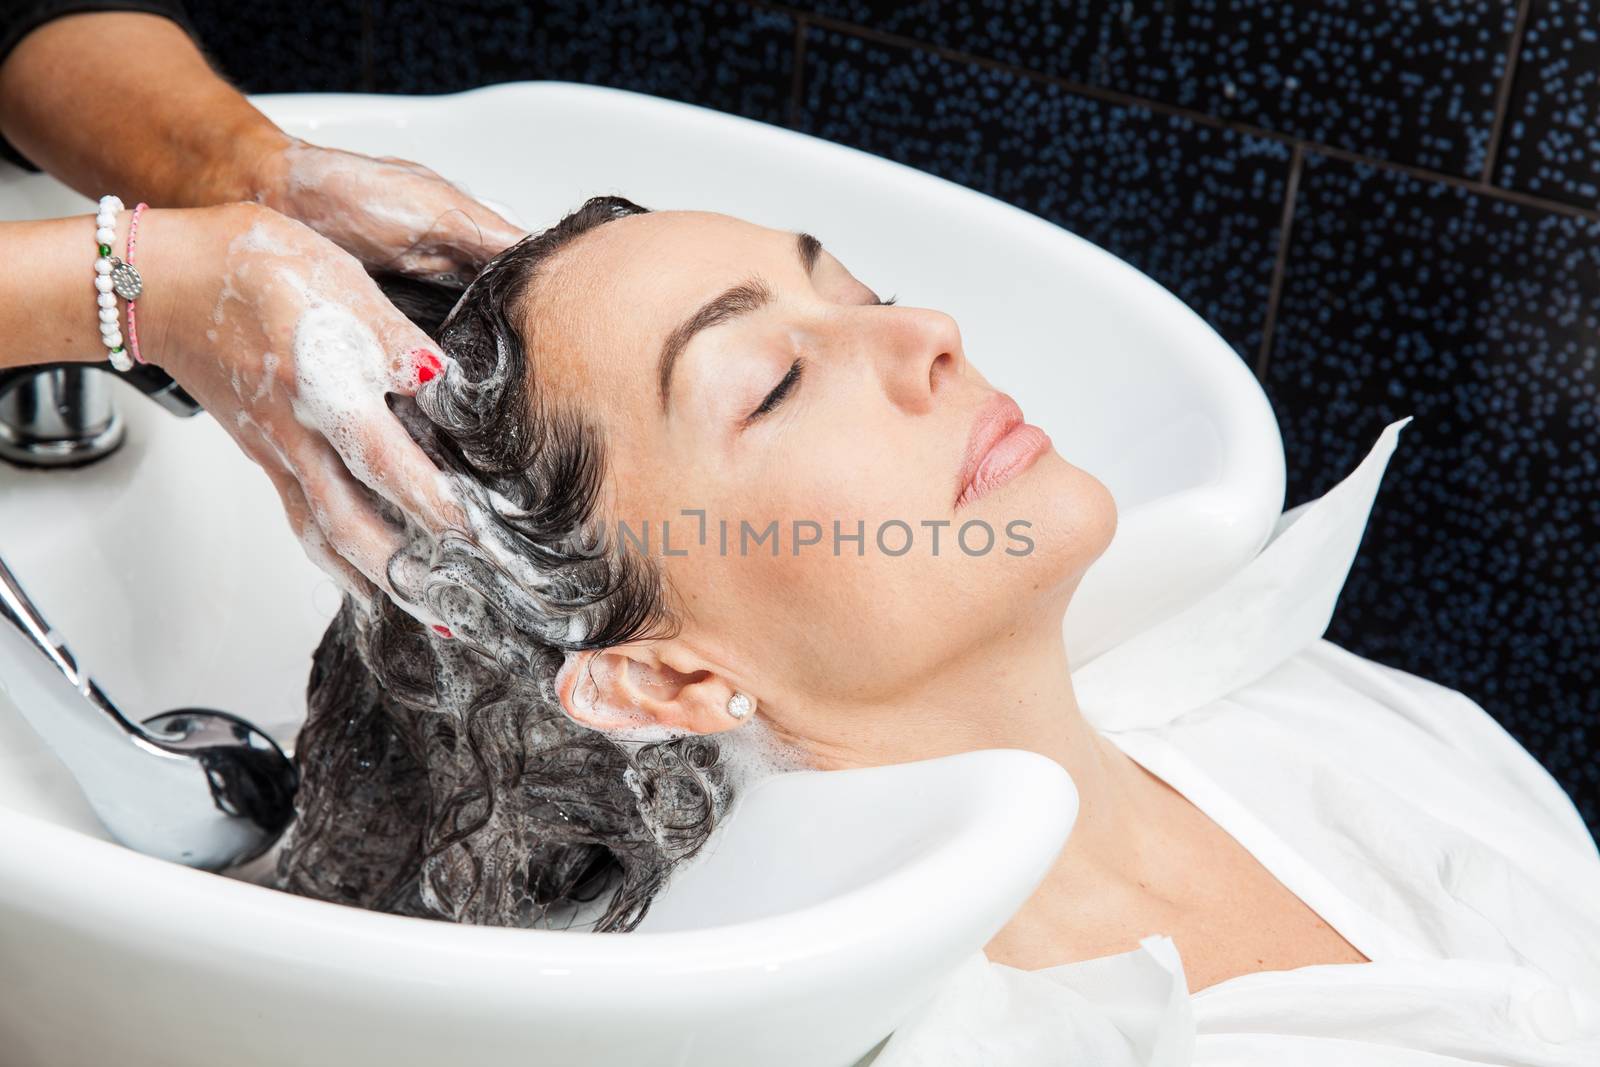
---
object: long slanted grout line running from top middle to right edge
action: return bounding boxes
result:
[744,0,1600,221]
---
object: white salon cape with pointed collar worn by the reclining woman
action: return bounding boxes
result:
[862,419,1600,1067]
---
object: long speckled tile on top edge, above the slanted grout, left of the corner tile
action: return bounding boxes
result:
[798,0,1517,178]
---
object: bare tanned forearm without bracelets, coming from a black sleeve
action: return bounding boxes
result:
[0,11,290,206]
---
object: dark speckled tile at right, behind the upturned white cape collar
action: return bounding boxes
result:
[1264,154,1600,829]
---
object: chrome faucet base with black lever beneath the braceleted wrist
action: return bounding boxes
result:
[0,363,200,467]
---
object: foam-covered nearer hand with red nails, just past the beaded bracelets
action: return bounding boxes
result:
[135,203,466,624]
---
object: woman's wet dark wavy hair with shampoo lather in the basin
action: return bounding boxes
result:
[277,197,731,931]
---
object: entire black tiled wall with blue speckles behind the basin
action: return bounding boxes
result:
[147,0,1600,829]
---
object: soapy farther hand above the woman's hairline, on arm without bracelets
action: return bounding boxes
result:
[256,139,526,282]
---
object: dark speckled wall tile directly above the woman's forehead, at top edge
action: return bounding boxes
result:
[373,0,795,123]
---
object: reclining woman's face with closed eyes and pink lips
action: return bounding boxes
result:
[523,211,1117,735]
